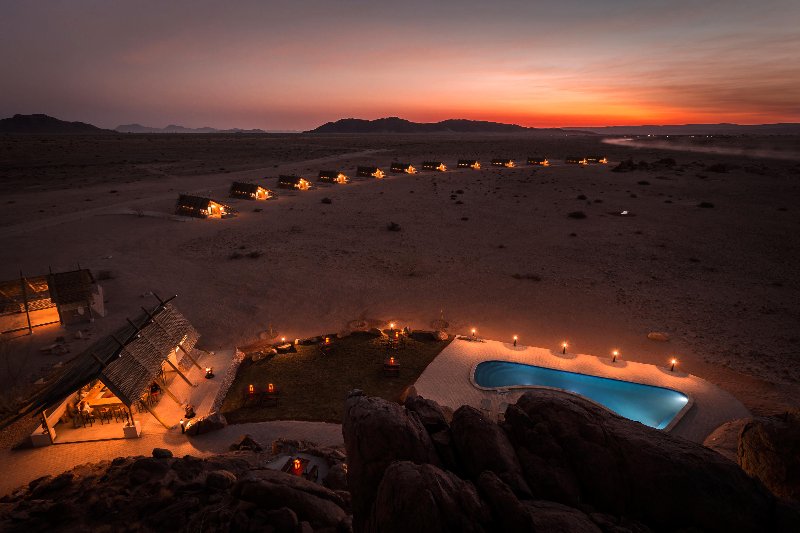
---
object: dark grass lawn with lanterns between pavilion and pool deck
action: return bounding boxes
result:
[222,334,450,424]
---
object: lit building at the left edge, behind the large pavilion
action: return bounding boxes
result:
[0,269,106,336]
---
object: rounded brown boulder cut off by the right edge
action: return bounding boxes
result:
[737,410,800,503]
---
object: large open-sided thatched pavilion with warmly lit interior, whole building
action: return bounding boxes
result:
[3,297,202,446]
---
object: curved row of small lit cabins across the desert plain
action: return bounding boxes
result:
[175,156,608,218]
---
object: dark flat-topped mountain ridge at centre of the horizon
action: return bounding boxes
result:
[305,117,577,133]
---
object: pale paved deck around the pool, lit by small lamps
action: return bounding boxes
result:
[414,338,750,442]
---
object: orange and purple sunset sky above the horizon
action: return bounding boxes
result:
[0,0,800,129]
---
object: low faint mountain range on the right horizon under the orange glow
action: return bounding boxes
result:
[564,122,800,135]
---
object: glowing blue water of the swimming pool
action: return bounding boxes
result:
[475,361,689,429]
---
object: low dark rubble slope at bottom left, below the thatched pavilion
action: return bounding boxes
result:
[0,449,351,533]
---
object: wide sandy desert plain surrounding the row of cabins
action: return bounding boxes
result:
[0,135,800,428]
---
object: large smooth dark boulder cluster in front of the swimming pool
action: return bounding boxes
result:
[343,391,800,533]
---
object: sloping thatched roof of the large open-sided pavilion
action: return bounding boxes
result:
[2,302,199,427]
